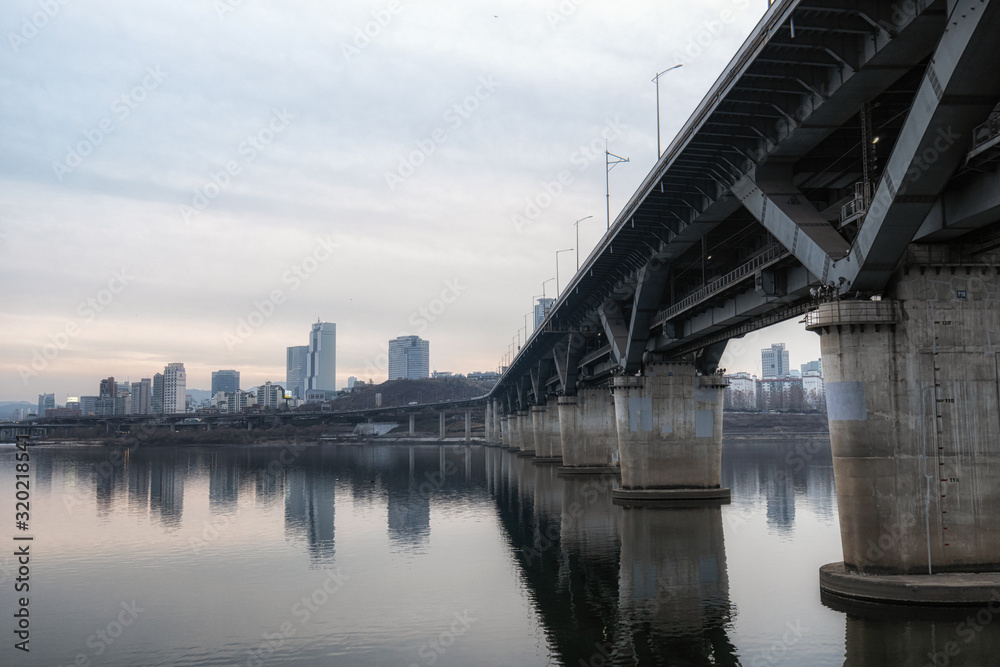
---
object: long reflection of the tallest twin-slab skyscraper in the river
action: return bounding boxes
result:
[285,448,336,565]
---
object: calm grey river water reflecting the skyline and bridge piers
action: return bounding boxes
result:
[0,440,1000,667]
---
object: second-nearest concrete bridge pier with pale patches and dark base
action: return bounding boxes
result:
[612,362,730,504]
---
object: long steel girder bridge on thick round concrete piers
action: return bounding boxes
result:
[486,0,1000,603]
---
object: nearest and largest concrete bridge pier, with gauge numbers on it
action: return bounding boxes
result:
[806,246,1000,604]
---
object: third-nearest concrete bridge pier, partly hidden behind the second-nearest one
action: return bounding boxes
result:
[558,387,618,474]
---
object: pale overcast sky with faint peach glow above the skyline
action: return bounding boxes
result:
[0,0,819,403]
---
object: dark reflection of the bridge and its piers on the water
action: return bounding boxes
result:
[486,450,739,666]
